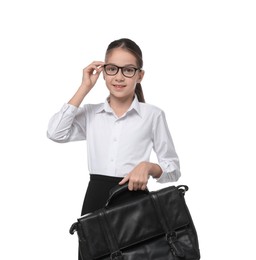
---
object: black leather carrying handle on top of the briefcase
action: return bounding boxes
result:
[105,183,149,207]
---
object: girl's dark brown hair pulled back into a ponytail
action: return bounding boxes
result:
[106,38,145,103]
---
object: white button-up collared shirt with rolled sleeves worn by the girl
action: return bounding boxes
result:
[47,97,180,183]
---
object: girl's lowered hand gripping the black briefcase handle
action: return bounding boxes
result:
[119,162,151,191]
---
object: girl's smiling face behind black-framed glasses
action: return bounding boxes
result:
[103,48,144,99]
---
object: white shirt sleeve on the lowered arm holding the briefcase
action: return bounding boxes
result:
[153,111,181,183]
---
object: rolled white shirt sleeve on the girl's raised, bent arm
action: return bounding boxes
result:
[47,104,86,143]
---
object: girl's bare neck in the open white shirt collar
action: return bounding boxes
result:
[109,96,134,117]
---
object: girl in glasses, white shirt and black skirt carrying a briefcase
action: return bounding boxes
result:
[47,38,180,258]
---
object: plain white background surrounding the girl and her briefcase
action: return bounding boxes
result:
[0,0,256,260]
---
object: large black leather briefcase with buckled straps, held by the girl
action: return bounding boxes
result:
[70,185,200,260]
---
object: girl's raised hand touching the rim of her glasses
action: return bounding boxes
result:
[81,61,105,91]
